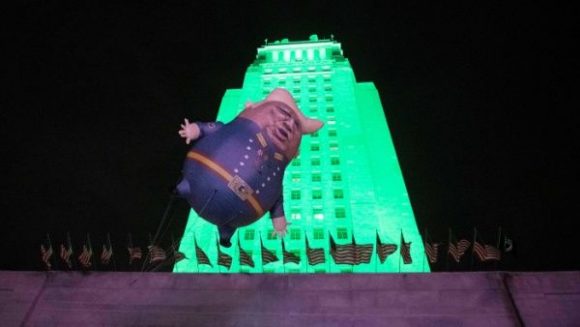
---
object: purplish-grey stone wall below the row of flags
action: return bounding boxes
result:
[0,272,580,327]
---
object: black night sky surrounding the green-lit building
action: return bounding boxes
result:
[0,1,580,271]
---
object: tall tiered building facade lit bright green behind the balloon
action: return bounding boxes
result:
[174,35,429,273]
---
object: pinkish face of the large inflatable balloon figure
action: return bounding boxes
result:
[240,101,302,159]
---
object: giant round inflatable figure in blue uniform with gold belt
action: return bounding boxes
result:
[176,88,322,247]
